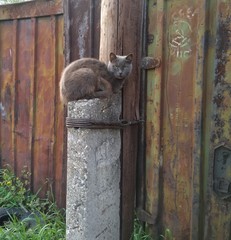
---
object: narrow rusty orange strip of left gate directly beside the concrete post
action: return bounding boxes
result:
[54,16,67,208]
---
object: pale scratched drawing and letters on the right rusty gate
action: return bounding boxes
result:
[169,8,198,58]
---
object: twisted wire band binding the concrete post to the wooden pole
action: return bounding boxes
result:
[66,117,144,129]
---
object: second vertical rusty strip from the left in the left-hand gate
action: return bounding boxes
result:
[15,19,34,176]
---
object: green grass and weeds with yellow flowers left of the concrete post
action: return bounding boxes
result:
[0,169,66,240]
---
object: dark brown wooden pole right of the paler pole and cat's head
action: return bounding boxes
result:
[117,0,143,240]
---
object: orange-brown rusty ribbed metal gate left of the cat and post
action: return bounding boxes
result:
[0,0,66,207]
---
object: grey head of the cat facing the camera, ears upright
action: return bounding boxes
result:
[108,53,133,79]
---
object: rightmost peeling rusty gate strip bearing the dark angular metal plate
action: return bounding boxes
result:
[201,0,231,239]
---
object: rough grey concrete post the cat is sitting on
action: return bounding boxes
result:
[66,94,121,240]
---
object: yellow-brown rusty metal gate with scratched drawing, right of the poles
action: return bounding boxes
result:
[143,0,231,240]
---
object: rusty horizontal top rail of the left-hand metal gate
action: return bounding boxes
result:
[0,0,63,20]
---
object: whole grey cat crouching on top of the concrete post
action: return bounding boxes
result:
[60,53,133,104]
